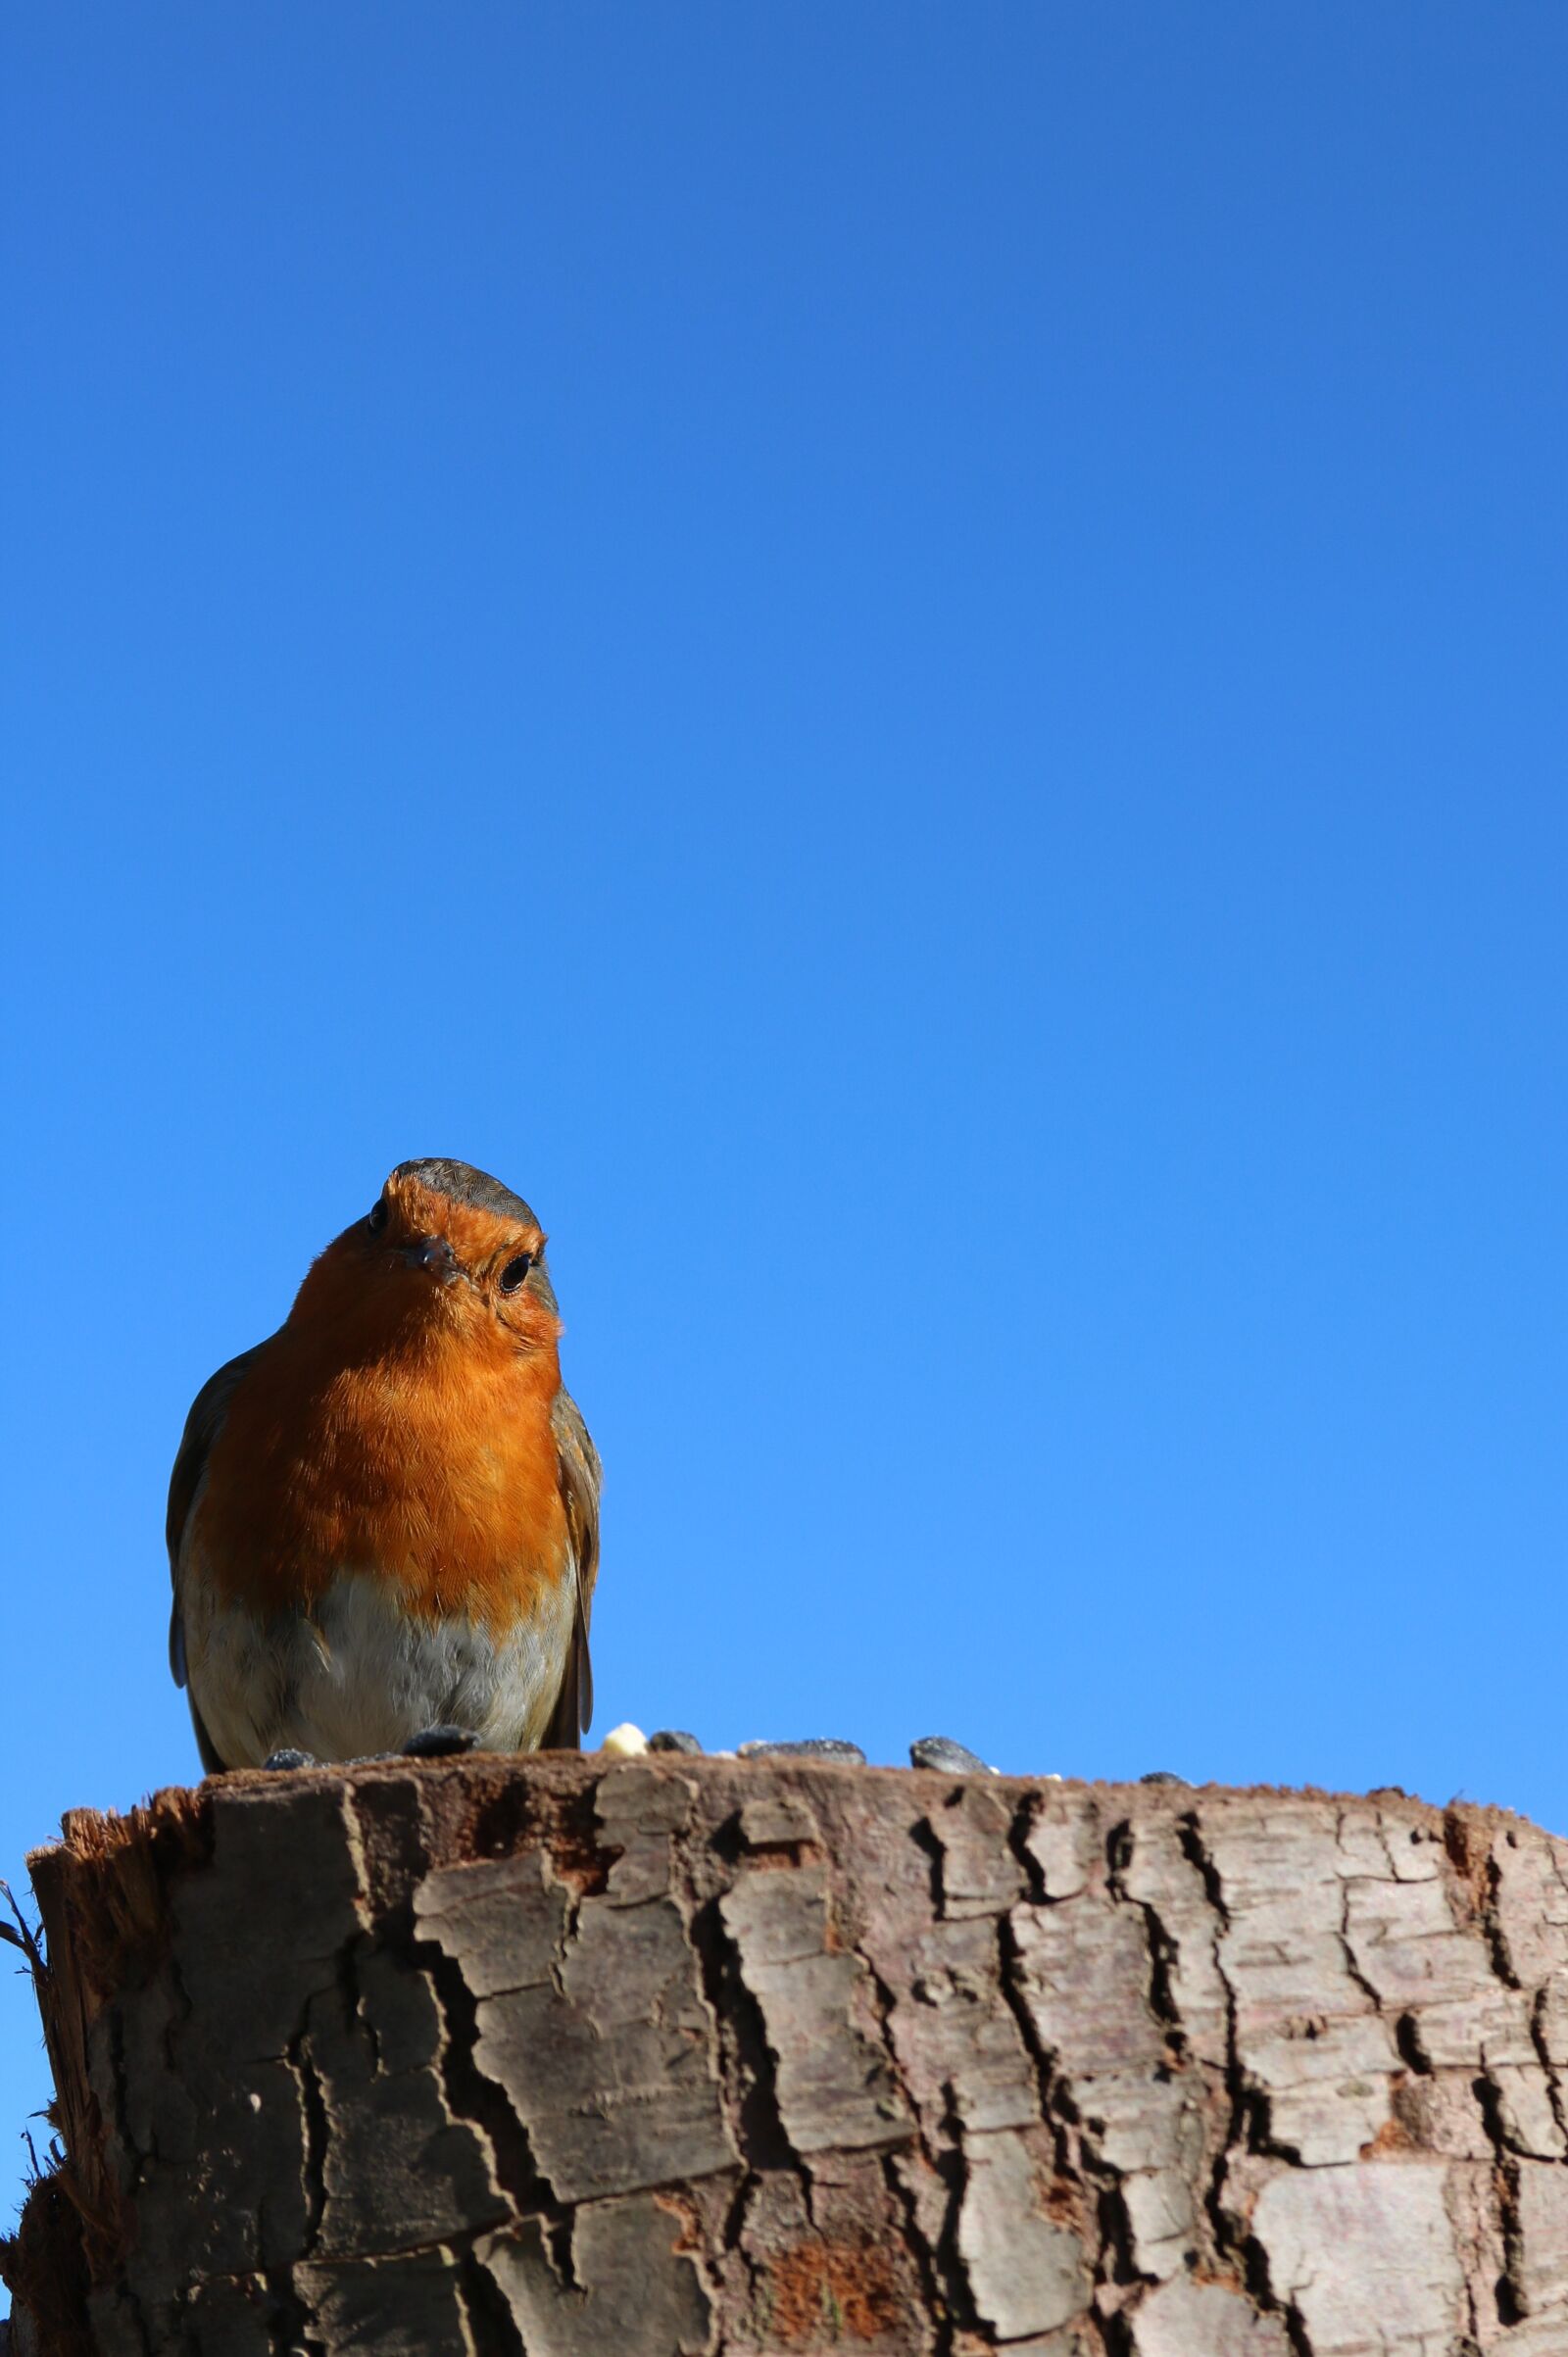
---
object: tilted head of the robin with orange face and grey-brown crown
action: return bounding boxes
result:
[290,1159,562,1352]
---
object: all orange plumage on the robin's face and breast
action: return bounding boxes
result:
[191,1181,570,1636]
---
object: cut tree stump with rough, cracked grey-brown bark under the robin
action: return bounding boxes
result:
[7,1756,1568,2357]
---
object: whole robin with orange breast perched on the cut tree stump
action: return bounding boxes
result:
[168,1162,599,1770]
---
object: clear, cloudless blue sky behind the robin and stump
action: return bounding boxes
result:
[0,0,1568,2243]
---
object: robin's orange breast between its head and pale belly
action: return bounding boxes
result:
[188,1291,568,1634]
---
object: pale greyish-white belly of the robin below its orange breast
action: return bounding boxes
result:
[184,1572,573,1768]
